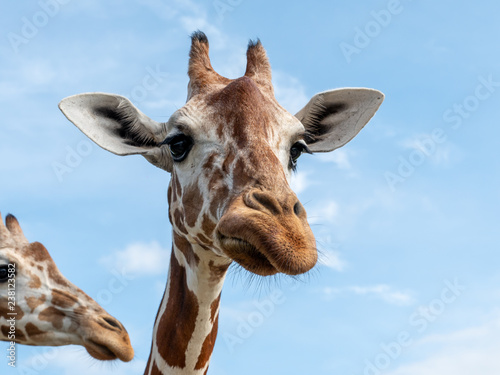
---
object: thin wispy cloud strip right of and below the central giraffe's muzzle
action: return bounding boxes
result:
[323,284,414,306]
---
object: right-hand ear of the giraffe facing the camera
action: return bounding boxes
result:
[295,88,384,152]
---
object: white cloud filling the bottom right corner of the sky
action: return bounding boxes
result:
[387,315,500,375]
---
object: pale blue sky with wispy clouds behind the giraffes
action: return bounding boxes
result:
[0,0,500,375]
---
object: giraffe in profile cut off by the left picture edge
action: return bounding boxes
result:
[0,214,134,362]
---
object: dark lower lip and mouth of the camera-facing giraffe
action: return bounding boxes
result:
[218,232,279,276]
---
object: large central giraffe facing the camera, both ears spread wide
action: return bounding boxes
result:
[59,31,384,374]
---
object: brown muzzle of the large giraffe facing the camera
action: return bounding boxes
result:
[216,189,318,276]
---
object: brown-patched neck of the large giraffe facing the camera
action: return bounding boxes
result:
[145,232,228,375]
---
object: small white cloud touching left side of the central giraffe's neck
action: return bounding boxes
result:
[99,241,170,275]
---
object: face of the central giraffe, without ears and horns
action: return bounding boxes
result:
[166,77,317,275]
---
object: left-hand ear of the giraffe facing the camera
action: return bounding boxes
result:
[59,93,172,172]
